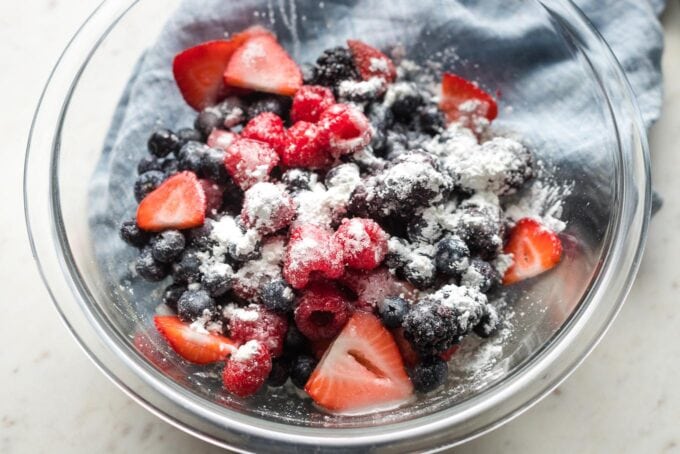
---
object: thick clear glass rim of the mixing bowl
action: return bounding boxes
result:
[24,0,651,452]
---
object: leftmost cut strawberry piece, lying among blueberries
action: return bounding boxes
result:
[137,171,207,232]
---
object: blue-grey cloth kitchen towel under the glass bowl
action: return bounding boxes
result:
[90,0,665,290]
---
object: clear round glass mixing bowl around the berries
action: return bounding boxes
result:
[24,0,650,452]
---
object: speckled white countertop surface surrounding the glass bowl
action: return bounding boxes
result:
[0,0,680,454]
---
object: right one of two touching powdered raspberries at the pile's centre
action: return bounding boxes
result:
[335,218,387,270]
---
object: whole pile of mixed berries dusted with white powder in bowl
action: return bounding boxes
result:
[120,27,561,413]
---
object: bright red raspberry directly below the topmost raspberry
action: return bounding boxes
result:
[281,121,331,169]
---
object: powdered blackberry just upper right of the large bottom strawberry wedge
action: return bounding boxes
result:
[402,299,460,356]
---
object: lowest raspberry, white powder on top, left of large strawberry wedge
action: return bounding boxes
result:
[222,340,272,397]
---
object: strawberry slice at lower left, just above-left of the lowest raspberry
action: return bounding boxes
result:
[153,315,238,364]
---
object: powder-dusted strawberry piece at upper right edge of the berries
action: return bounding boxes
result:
[439,73,498,126]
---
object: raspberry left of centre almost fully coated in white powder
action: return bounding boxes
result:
[241,183,295,235]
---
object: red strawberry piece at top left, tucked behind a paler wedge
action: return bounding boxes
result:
[172,26,271,110]
